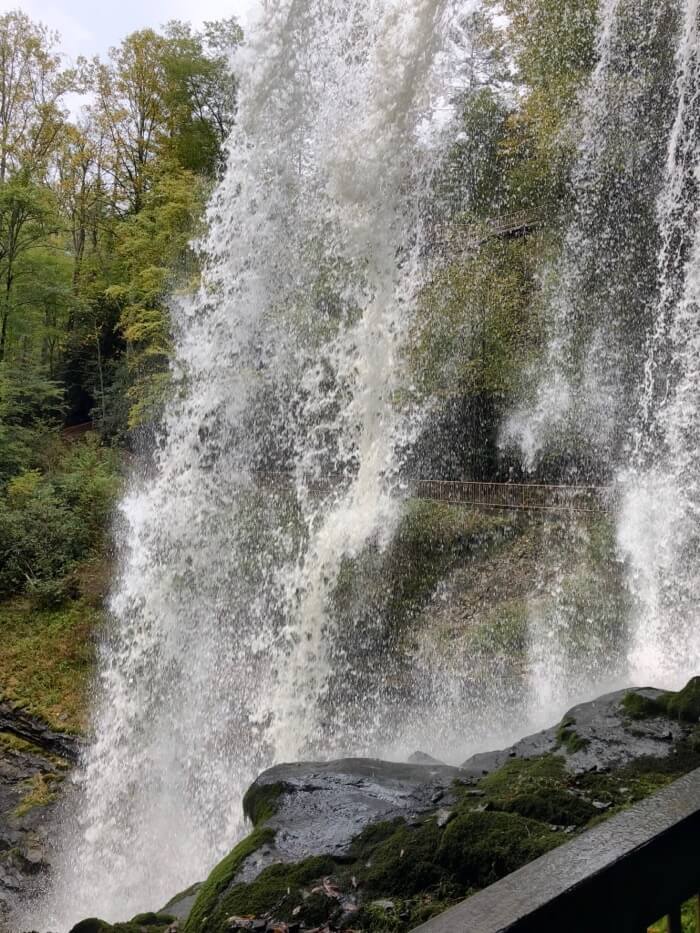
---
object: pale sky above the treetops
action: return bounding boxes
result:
[0,0,258,64]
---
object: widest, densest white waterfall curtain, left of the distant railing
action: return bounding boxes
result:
[29,0,476,929]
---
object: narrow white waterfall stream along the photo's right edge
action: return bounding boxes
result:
[619,0,700,687]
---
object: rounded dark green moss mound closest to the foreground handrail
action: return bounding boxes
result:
[437,812,566,888]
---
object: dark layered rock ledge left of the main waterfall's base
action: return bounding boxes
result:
[0,702,78,933]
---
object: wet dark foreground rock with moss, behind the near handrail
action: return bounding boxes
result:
[57,678,700,933]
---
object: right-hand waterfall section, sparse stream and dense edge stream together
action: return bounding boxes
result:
[503,0,700,697]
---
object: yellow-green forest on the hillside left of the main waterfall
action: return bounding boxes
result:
[0,11,241,605]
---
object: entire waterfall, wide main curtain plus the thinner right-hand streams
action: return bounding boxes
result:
[19,0,700,930]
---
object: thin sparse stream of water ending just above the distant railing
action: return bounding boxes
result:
[503,0,678,470]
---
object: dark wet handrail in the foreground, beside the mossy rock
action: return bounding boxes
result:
[416,769,700,933]
